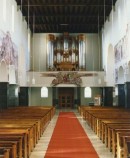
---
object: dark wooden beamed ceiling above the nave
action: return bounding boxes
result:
[16,0,117,33]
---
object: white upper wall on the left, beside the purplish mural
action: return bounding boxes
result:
[0,0,30,86]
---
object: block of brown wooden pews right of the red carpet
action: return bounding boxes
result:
[78,106,130,158]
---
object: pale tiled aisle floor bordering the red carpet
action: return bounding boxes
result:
[30,109,113,158]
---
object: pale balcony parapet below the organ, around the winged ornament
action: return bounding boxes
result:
[27,71,106,87]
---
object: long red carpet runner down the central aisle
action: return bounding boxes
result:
[45,112,98,158]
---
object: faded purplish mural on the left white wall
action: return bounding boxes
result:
[0,30,18,82]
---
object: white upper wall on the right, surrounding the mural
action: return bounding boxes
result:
[102,0,130,84]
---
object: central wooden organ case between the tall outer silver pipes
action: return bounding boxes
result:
[49,33,84,71]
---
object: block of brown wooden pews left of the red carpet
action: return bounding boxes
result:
[0,106,55,158]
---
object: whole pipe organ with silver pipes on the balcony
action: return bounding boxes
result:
[47,33,85,71]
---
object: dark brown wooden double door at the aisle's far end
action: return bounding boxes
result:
[59,88,74,108]
